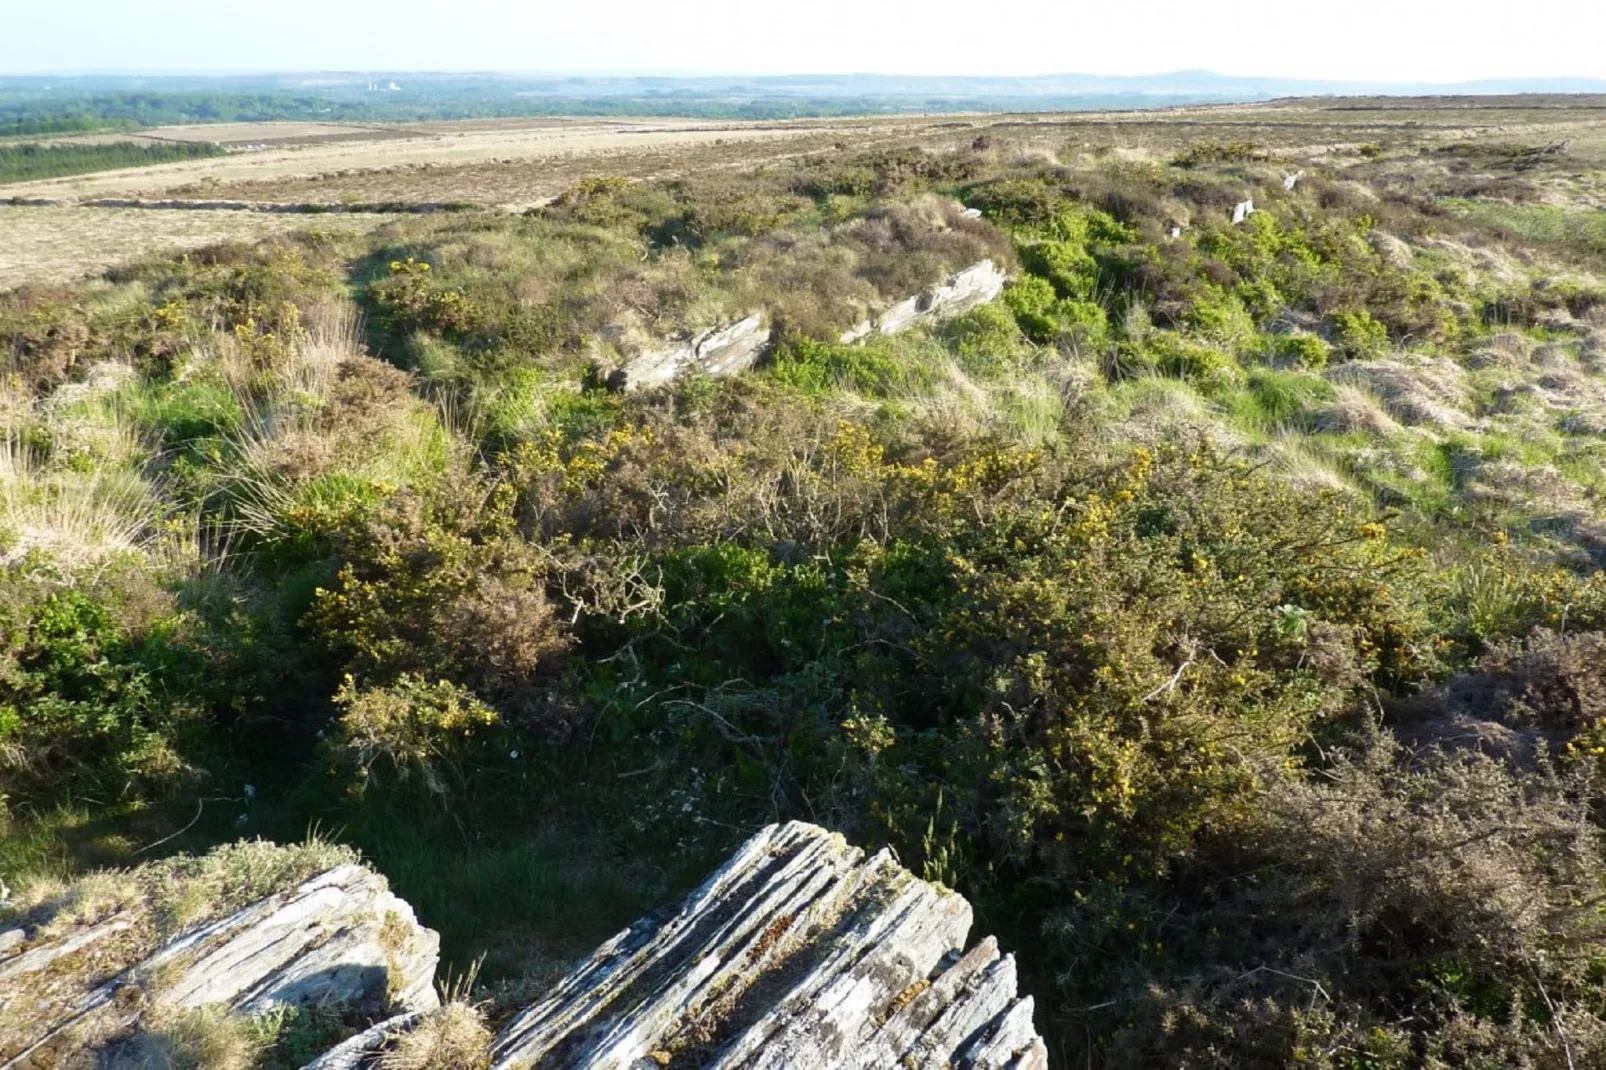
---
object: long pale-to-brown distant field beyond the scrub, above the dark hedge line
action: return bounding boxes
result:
[9,96,1606,207]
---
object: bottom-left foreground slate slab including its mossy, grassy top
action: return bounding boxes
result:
[0,845,440,1068]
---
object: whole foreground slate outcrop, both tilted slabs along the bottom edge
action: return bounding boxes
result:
[0,823,1047,1070]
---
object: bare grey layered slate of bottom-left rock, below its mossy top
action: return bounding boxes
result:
[0,864,440,1068]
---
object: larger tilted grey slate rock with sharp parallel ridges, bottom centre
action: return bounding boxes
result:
[491,823,1047,1070]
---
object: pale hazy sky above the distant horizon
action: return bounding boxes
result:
[0,0,1606,82]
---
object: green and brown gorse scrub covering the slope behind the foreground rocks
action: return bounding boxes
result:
[0,102,1606,1070]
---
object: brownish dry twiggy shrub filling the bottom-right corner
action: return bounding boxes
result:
[1079,737,1606,1070]
